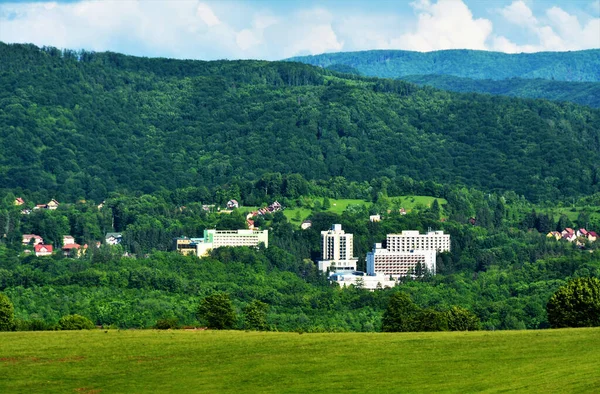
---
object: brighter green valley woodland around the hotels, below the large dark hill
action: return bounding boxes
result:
[0,182,600,332]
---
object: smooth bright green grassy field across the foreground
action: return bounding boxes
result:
[0,328,600,393]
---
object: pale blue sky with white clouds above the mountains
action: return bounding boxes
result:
[0,0,600,60]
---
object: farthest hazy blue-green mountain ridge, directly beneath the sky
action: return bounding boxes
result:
[288,49,600,82]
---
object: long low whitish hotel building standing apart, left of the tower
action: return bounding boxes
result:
[195,229,269,257]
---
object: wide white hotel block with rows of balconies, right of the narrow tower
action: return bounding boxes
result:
[367,231,450,278]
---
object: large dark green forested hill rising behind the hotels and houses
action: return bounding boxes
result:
[0,44,600,201]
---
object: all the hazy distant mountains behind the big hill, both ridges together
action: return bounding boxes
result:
[289,49,600,108]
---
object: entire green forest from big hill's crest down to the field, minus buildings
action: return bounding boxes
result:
[0,44,600,332]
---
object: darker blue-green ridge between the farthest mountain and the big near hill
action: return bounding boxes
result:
[402,75,600,108]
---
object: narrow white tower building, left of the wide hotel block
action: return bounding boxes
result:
[317,224,358,271]
